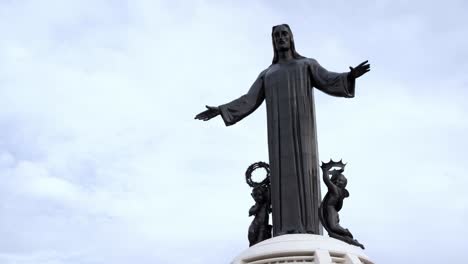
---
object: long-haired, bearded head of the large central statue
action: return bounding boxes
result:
[271,24,304,64]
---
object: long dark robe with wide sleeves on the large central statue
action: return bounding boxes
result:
[219,58,354,236]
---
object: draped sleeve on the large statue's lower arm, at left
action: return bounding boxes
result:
[219,70,266,126]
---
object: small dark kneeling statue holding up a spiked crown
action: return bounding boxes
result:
[319,160,364,249]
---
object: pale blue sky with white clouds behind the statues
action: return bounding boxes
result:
[0,0,468,264]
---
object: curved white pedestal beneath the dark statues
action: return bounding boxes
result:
[232,234,374,264]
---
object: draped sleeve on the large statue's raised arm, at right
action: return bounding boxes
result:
[308,59,355,98]
